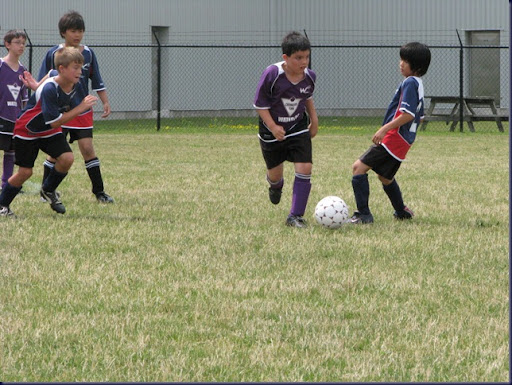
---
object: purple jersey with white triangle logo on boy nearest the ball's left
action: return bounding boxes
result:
[254,62,316,140]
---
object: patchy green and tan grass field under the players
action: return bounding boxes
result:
[0,120,510,382]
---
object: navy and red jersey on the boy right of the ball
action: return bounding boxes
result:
[382,76,425,161]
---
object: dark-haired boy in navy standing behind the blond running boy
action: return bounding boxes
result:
[38,11,114,203]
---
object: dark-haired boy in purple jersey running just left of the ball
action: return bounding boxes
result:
[254,32,318,227]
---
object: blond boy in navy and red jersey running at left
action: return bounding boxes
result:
[0,48,96,217]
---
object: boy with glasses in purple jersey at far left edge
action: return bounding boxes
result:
[0,30,28,189]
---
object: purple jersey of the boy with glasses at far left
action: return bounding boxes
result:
[0,59,28,130]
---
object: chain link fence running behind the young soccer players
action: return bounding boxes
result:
[22,44,510,132]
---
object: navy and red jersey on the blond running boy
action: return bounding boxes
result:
[14,77,86,140]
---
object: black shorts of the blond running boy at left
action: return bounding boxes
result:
[14,134,71,168]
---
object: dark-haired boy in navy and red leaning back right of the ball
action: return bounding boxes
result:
[351,42,430,224]
